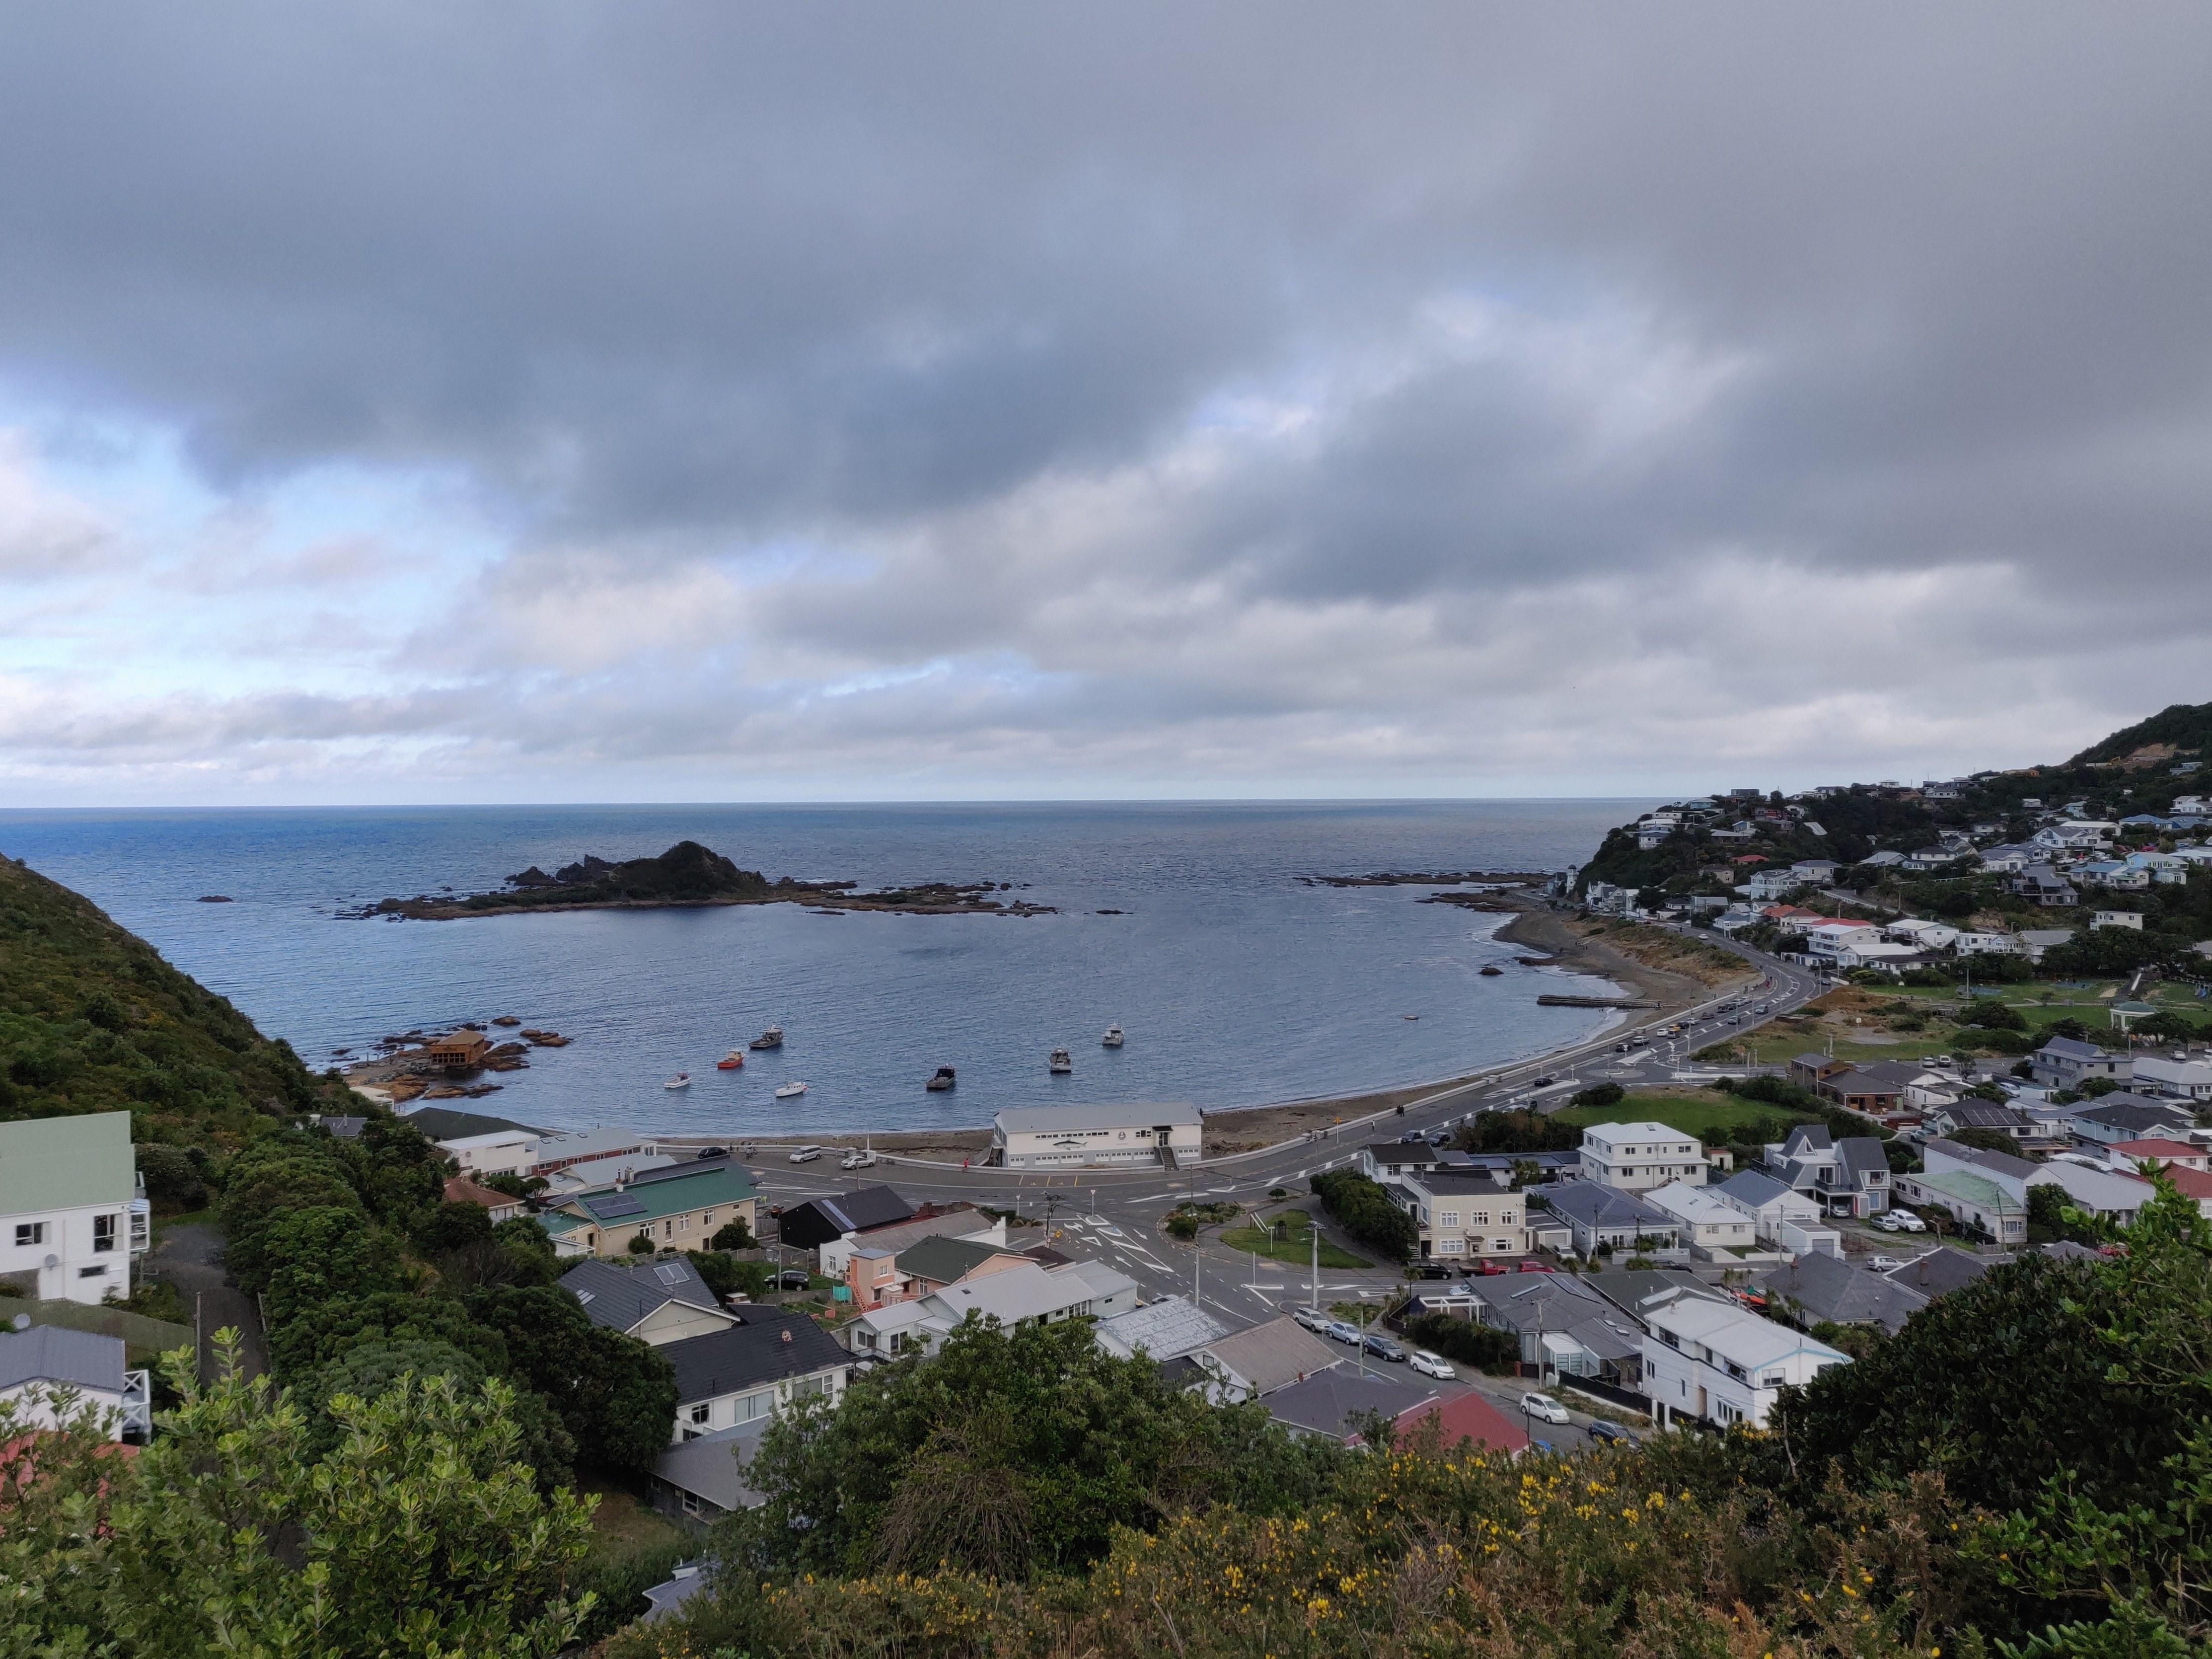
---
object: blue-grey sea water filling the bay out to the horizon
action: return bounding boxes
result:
[0,801,1643,1137]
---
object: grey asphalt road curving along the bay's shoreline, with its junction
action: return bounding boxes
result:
[754,936,1825,1325]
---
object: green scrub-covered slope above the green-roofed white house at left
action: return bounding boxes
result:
[0,856,318,1146]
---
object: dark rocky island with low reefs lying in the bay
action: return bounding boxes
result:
[341,840,1053,922]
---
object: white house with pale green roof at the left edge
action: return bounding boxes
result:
[0,1113,152,1303]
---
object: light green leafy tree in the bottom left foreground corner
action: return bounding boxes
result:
[0,1332,590,1659]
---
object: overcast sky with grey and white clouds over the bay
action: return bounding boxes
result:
[0,0,2212,805]
